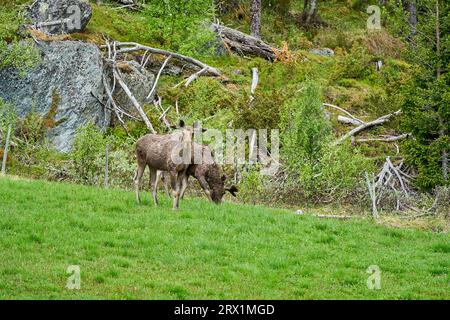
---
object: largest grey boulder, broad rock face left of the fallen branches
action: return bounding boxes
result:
[0,41,110,152]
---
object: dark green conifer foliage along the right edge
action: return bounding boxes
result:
[388,0,450,190]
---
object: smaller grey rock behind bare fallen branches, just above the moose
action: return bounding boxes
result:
[114,60,155,117]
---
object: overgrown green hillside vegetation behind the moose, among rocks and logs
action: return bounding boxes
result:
[0,0,450,222]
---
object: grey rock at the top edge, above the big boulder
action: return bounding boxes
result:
[25,0,92,34]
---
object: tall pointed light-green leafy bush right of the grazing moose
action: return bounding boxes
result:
[281,81,371,200]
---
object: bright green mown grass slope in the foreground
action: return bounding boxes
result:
[0,178,450,299]
